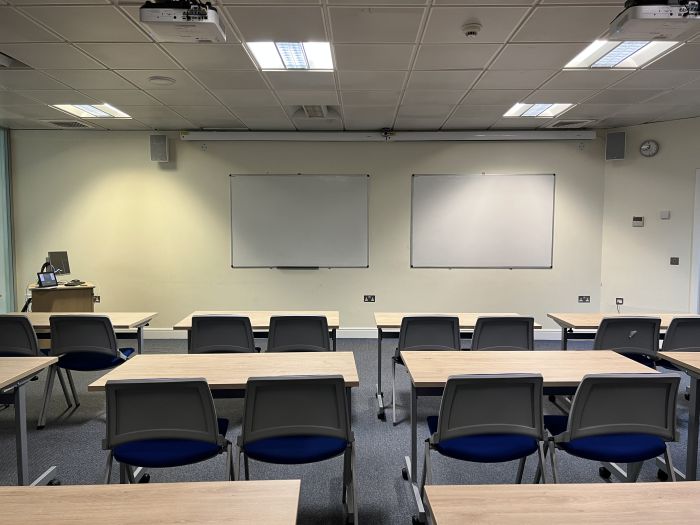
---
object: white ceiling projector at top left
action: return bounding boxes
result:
[139,0,226,43]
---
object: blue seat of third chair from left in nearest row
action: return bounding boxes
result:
[428,416,537,463]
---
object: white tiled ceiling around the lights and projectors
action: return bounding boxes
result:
[0,0,700,130]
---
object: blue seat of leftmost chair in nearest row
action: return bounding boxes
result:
[114,418,228,468]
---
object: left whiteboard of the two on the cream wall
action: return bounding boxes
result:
[229,175,369,268]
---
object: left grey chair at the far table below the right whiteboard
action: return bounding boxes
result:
[391,316,460,425]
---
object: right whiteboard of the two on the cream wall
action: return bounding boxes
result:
[411,174,555,268]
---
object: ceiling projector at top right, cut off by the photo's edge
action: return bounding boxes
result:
[606,0,700,41]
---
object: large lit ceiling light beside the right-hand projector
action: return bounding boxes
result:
[564,40,679,69]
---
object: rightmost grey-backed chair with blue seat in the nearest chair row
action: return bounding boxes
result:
[544,374,680,483]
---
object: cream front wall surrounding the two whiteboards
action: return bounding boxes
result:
[12,131,604,327]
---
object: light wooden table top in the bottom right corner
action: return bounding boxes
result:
[425,481,700,525]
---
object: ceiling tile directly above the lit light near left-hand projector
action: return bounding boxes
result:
[226,6,329,42]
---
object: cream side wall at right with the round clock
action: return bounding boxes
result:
[601,118,700,312]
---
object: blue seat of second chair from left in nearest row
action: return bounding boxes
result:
[244,436,348,465]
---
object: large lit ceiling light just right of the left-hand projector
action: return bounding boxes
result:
[248,42,333,70]
